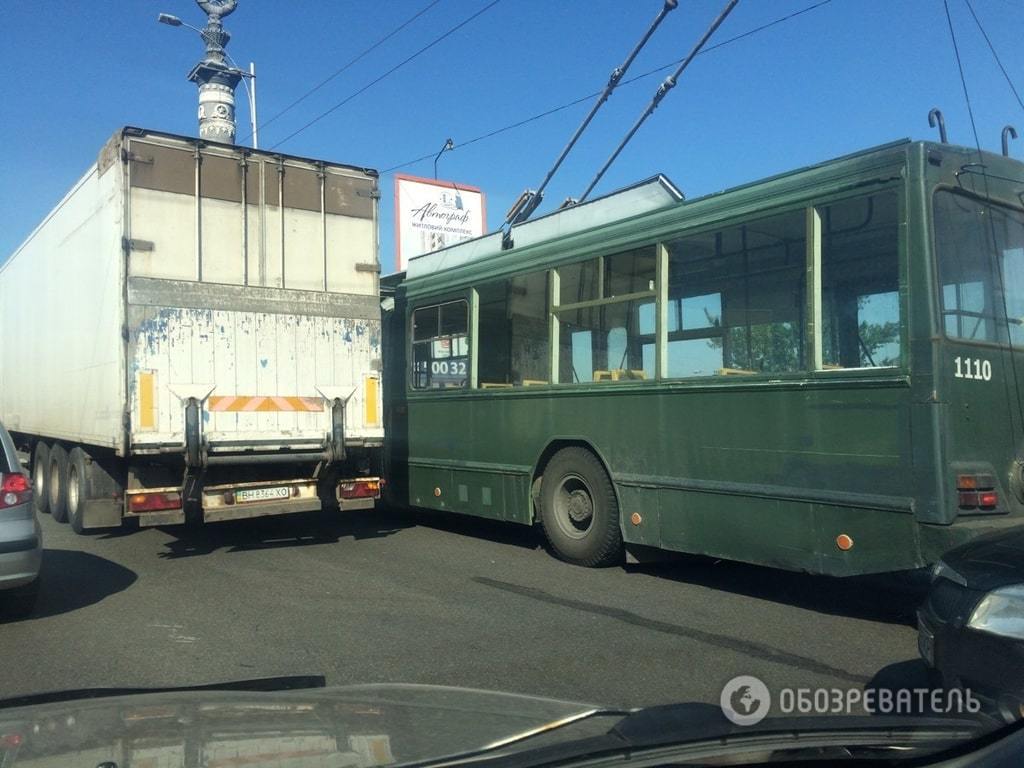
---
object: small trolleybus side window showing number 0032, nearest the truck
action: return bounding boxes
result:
[413,301,469,389]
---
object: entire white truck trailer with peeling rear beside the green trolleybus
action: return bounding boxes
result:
[0,128,383,531]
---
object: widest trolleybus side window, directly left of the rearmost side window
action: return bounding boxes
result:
[666,210,807,378]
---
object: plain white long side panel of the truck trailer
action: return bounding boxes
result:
[0,151,126,453]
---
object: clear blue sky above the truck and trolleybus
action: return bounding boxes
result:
[0,0,1024,271]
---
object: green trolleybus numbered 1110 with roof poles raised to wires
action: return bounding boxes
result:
[384,141,1024,575]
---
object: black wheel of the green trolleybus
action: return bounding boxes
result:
[541,447,623,567]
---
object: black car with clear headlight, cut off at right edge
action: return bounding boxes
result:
[918,526,1024,721]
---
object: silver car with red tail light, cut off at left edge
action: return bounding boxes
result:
[0,424,43,620]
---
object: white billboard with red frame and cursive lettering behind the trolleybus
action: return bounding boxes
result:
[394,174,487,272]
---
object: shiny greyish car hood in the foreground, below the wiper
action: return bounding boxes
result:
[0,685,617,768]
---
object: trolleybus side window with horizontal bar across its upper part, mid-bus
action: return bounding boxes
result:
[555,245,656,384]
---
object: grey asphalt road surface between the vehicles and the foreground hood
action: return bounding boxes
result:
[0,511,921,706]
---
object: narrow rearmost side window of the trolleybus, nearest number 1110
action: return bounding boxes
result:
[818,191,901,370]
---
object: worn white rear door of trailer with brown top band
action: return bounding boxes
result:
[125,136,383,452]
